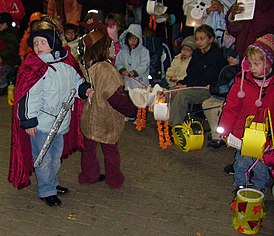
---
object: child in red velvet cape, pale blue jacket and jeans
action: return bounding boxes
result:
[9,26,93,206]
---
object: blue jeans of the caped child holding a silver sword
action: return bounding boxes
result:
[31,131,64,198]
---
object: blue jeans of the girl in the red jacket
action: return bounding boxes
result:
[234,151,269,193]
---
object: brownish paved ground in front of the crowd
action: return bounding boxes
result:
[0,96,274,236]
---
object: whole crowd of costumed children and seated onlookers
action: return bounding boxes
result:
[0,0,274,206]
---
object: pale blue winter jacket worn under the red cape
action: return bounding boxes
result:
[18,53,85,134]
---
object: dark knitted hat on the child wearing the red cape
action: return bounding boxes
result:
[28,29,63,51]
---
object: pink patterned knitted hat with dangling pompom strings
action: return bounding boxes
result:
[238,34,274,107]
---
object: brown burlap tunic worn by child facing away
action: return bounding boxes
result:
[81,62,125,144]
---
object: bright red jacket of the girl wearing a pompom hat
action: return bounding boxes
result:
[219,72,274,138]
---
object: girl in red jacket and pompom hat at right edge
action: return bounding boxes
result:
[218,34,274,193]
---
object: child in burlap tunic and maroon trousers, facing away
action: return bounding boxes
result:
[79,30,136,189]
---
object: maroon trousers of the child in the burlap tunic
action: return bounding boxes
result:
[79,137,124,188]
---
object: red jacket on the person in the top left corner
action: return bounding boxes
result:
[0,0,26,26]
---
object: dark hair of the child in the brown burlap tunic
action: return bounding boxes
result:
[84,35,111,64]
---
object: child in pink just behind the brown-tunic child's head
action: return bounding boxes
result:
[105,13,125,65]
